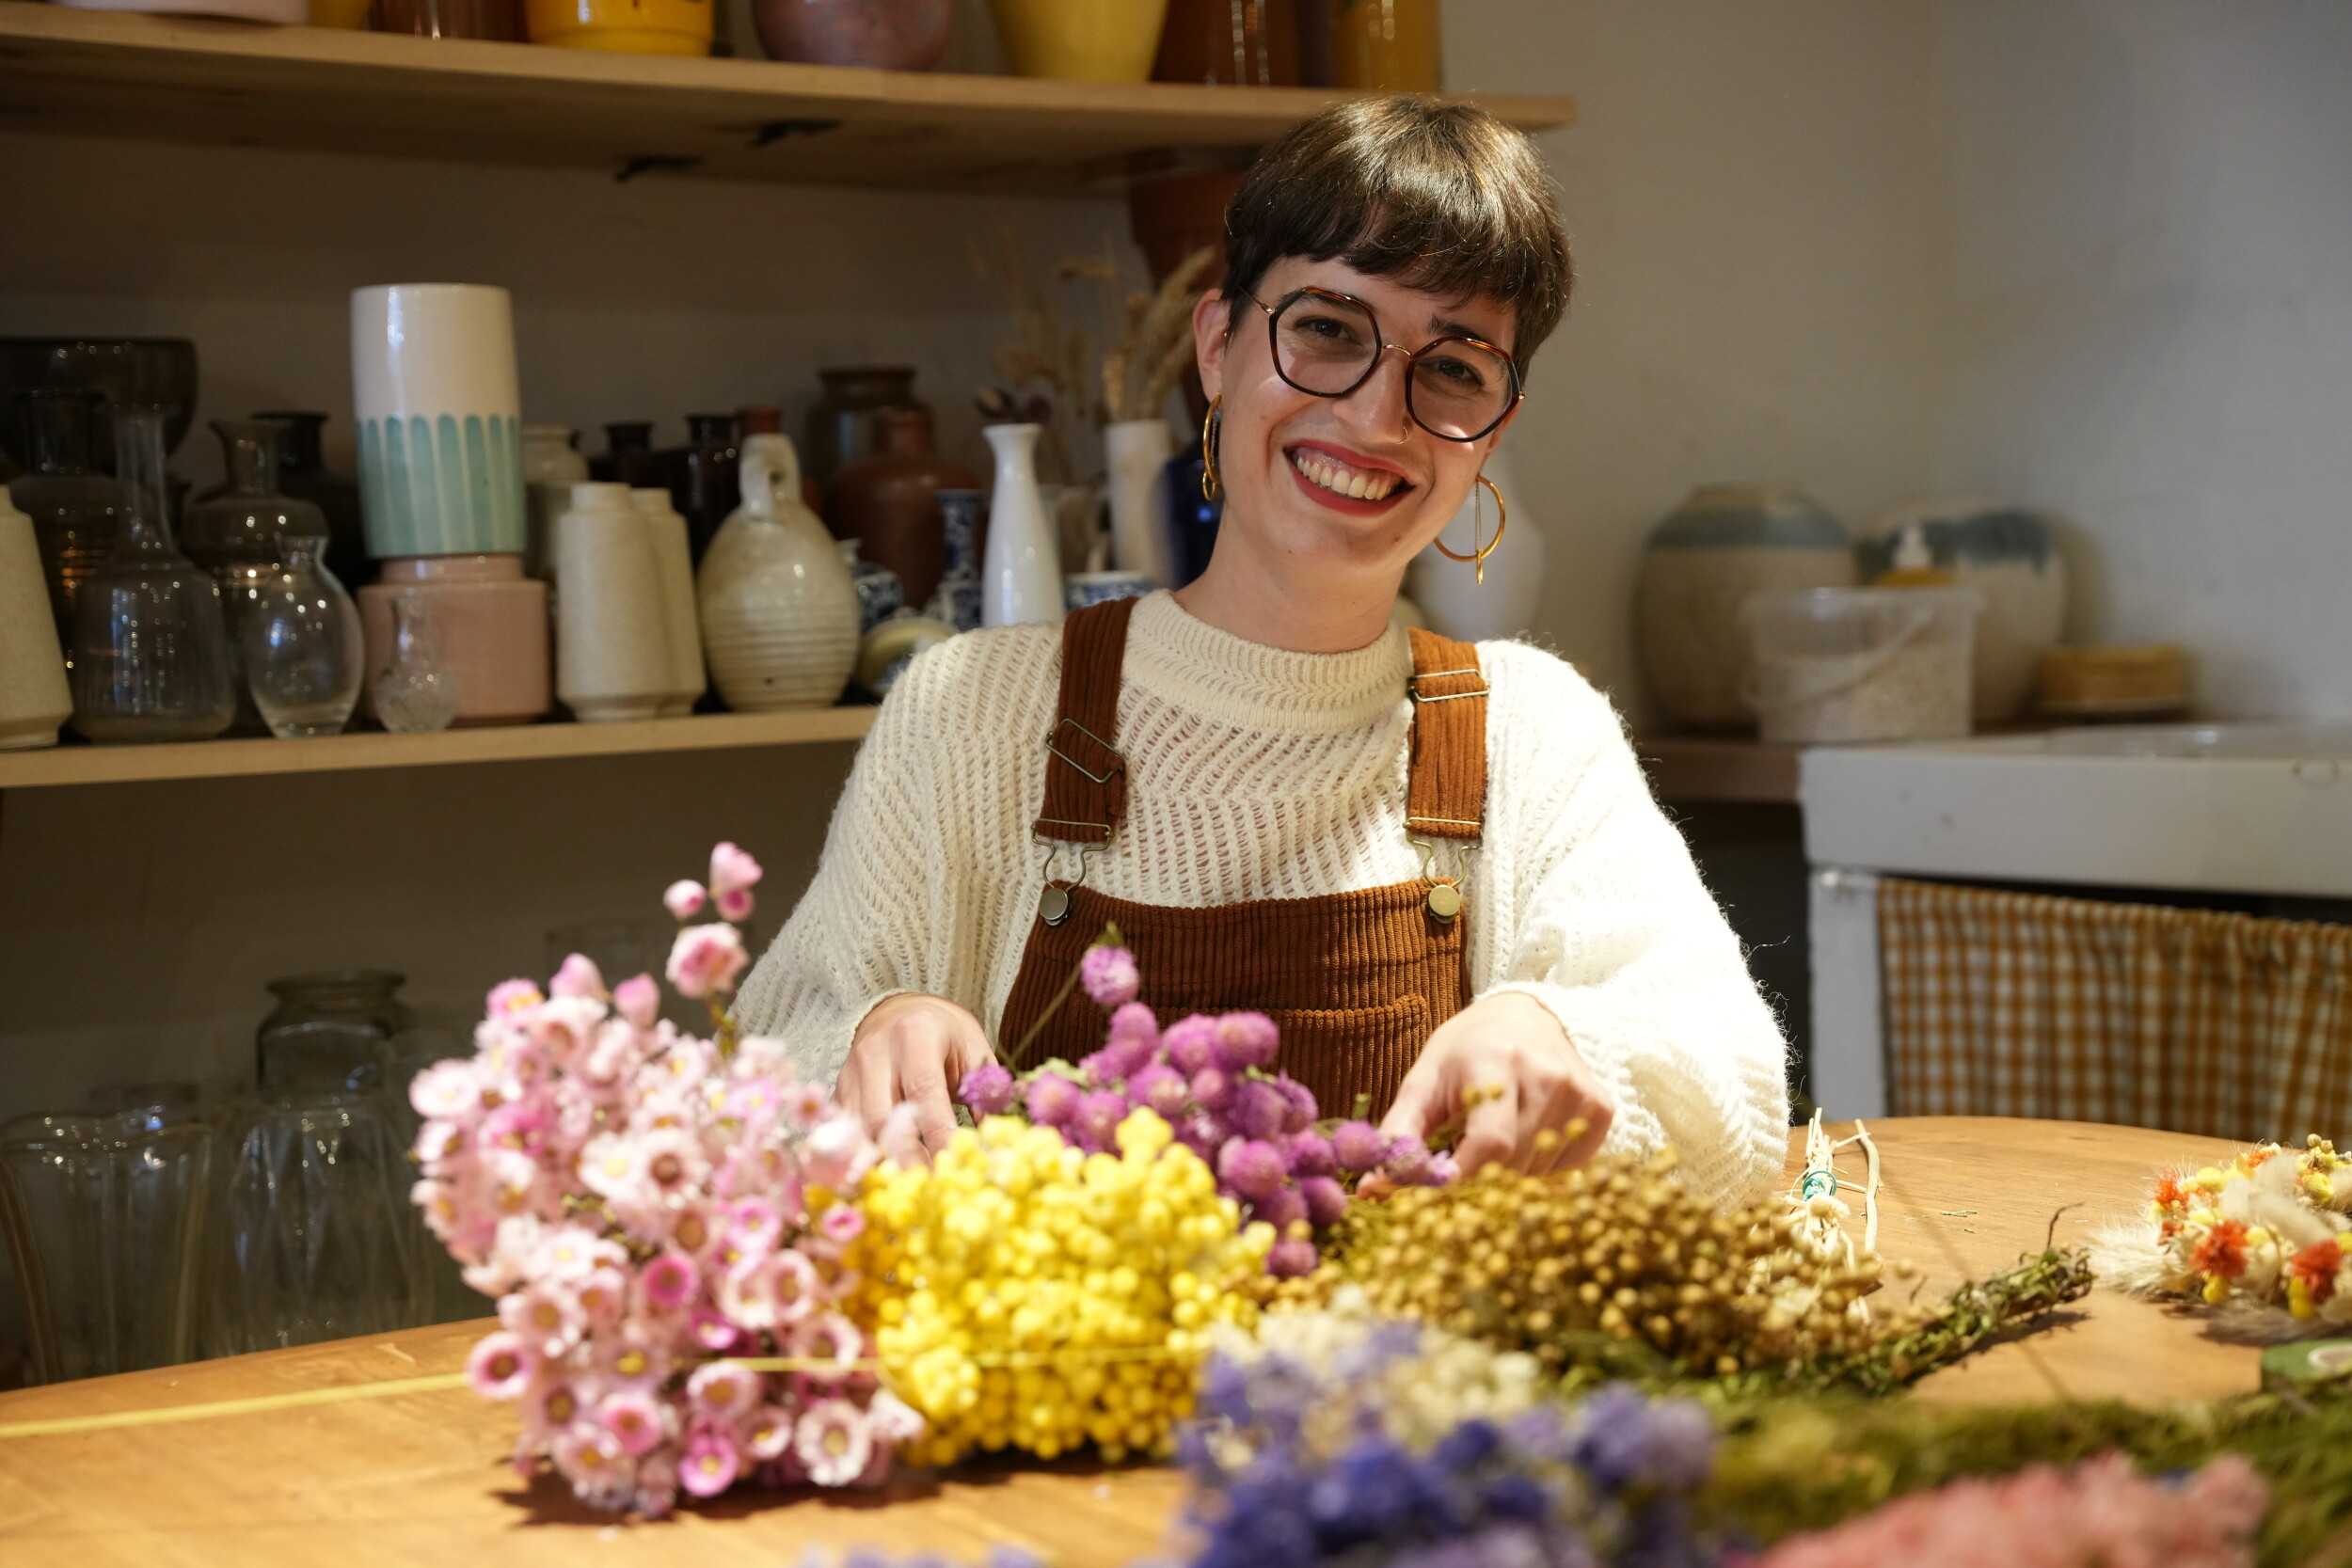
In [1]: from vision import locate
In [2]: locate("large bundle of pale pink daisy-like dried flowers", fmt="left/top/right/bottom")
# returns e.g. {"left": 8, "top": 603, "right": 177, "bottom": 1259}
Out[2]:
{"left": 409, "top": 844, "right": 922, "bottom": 1516}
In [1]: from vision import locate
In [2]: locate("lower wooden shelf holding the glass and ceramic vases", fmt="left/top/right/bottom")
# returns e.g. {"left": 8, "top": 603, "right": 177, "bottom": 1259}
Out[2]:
{"left": 0, "top": 707, "right": 878, "bottom": 790}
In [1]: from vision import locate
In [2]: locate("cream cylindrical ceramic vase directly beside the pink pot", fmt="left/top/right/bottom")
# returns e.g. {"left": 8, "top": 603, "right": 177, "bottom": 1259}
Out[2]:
{"left": 550, "top": 484, "right": 671, "bottom": 724}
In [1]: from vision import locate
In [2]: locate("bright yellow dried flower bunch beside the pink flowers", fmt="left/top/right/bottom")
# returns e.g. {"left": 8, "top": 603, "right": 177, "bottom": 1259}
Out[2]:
{"left": 847, "top": 1110, "right": 1275, "bottom": 1465}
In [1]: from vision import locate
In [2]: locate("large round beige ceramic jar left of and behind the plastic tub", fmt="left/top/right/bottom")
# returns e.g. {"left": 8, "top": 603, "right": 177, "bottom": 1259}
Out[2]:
{"left": 1635, "top": 484, "right": 1856, "bottom": 729}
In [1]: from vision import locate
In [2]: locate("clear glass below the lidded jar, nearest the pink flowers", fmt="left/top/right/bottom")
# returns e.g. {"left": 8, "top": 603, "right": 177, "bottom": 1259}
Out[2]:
{"left": 205, "top": 1091, "right": 431, "bottom": 1356}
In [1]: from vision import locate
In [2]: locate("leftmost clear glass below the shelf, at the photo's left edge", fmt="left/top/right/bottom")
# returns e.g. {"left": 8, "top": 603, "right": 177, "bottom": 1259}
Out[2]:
{"left": 0, "top": 1107, "right": 212, "bottom": 1383}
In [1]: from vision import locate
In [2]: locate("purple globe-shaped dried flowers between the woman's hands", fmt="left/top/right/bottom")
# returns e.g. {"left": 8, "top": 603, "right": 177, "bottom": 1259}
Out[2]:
{"left": 958, "top": 933, "right": 1456, "bottom": 1279}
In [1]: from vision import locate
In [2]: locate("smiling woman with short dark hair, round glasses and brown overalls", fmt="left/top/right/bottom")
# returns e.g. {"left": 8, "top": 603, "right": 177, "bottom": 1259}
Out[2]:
{"left": 739, "top": 99, "right": 1788, "bottom": 1199}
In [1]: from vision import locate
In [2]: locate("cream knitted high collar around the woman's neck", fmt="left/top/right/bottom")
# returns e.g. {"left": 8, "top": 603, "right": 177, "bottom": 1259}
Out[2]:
{"left": 1124, "top": 593, "right": 1414, "bottom": 736}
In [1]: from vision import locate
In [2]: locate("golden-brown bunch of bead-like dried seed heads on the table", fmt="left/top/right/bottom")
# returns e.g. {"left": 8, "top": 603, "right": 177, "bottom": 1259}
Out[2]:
{"left": 1278, "top": 1132, "right": 1924, "bottom": 1378}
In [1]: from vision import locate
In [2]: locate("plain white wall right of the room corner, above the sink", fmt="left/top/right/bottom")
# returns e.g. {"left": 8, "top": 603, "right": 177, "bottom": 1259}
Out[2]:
{"left": 1931, "top": 0, "right": 2352, "bottom": 720}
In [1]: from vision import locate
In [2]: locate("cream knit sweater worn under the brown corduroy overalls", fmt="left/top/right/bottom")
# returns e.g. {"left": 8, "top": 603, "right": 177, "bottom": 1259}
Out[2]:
{"left": 739, "top": 593, "right": 1788, "bottom": 1201}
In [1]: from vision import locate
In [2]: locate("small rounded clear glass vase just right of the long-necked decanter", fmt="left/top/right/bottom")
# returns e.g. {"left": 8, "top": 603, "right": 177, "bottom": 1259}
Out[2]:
{"left": 240, "top": 533, "right": 367, "bottom": 740}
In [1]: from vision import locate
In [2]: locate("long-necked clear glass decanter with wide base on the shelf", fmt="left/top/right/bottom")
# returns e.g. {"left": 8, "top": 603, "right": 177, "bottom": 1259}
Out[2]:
{"left": 73, "top": 406, "right": 238, "bottom": 743}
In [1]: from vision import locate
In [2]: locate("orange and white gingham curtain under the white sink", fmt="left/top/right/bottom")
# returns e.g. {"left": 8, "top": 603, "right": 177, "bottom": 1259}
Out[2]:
{"left": 1880, "top": 877, "right": 2352, "bottom": 1143}
